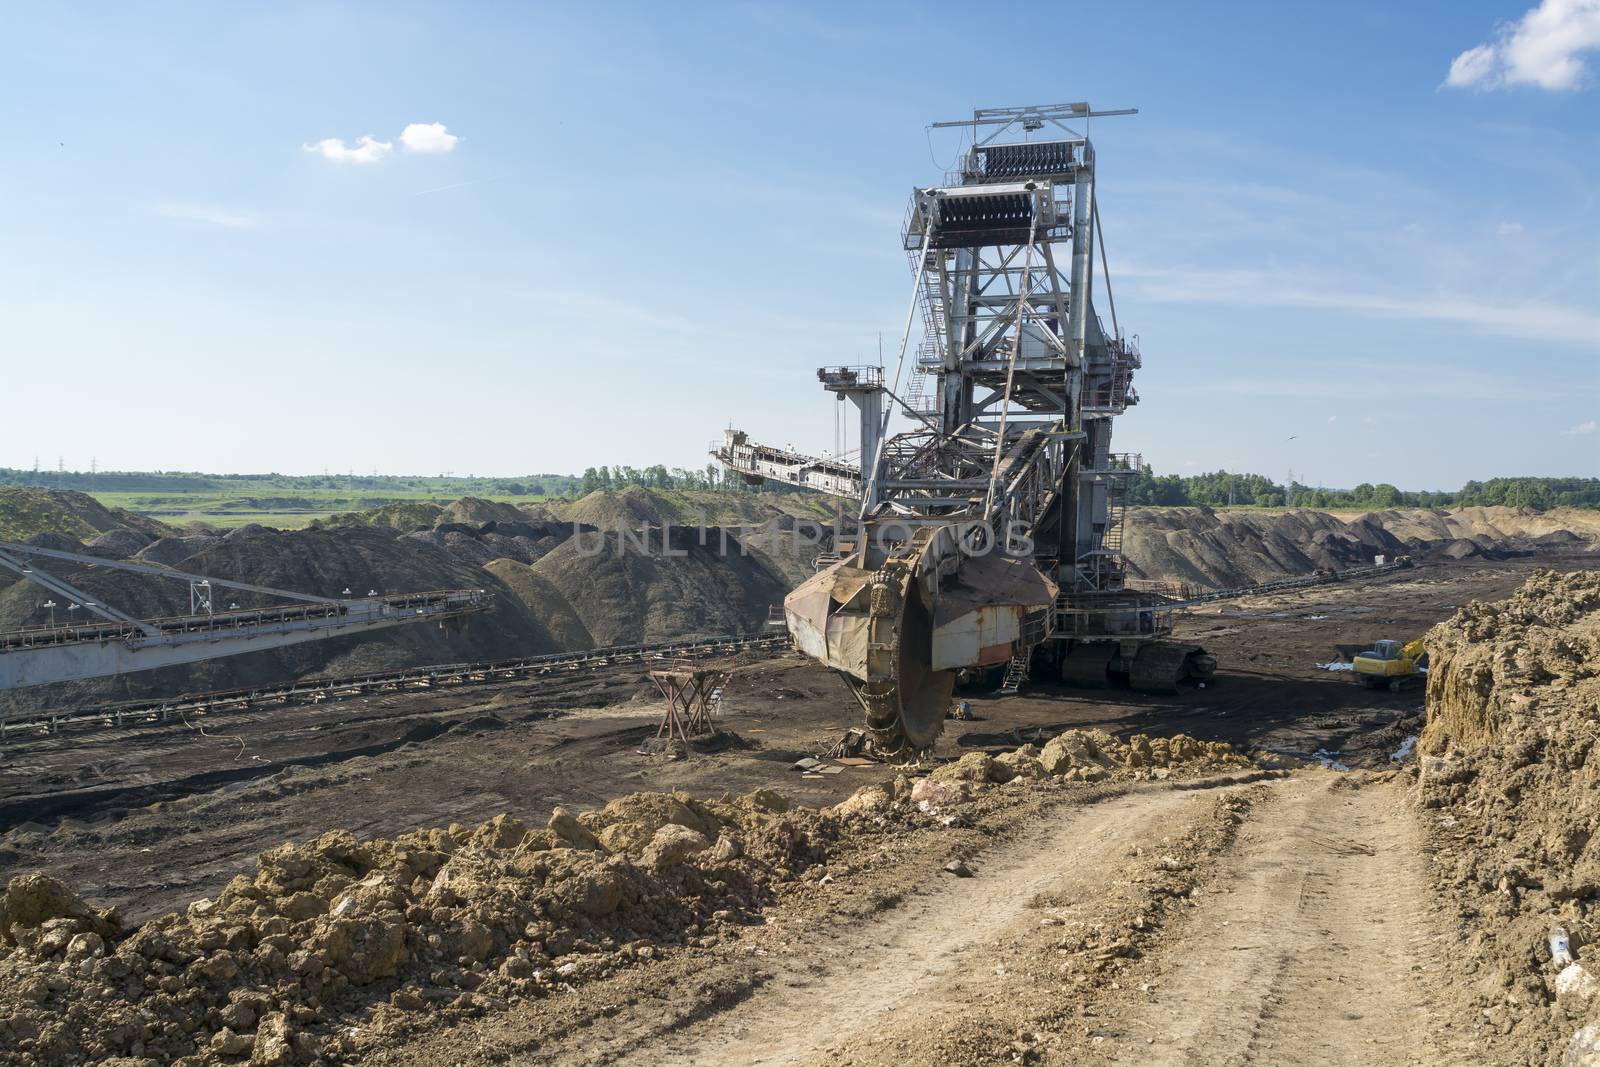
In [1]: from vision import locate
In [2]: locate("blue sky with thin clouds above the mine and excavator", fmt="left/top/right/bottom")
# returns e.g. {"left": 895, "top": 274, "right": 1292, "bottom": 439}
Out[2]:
{"left": 0, "top": 0, "right": 1600, "bottom": 488}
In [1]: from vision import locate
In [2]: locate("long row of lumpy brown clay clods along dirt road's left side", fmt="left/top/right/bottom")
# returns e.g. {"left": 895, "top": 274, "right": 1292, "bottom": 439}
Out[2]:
{"left": 0, "top": 731, "right": 1248, "bottom": 1067}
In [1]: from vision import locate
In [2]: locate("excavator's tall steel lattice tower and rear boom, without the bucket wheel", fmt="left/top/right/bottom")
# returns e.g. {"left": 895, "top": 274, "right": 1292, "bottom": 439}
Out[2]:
{"left": 712, "top": 104, "right": 1166, "bottom": 638}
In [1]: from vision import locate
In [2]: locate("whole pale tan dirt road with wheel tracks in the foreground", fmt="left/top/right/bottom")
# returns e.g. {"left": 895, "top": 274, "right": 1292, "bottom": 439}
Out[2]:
{"left": 376, "top": 771, "right": 1483, "bottom": 1067}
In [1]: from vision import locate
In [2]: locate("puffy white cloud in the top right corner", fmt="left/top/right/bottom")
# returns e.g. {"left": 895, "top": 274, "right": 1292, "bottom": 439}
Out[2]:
{"left": 1445, "top": 0, "right": 1600, "bottom": 91}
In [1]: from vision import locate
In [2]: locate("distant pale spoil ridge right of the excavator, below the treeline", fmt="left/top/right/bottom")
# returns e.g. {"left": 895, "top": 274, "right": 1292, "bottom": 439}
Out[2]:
{"left": 1123, "top": 507, "right": 1600, "bottom": 589}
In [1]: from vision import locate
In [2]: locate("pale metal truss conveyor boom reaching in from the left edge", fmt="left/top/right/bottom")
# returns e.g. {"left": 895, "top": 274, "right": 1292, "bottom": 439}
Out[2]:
{"left": 0, "top": 542, "right": 494, "bottom": 691}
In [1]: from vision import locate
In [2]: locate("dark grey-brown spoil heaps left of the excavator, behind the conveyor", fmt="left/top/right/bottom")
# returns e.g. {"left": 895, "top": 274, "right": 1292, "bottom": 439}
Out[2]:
{"left": 0, "top": 490, "right": 814, "bottom": 713}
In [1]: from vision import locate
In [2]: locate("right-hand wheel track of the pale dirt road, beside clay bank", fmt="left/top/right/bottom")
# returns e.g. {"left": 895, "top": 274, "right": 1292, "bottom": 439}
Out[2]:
{"left": 1114, "top": 774, "right": 1474, "bottom": 1065}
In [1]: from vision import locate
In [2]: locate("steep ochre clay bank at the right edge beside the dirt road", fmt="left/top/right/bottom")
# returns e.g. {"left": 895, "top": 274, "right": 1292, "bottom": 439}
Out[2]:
{"left": 1419, "top": 571, "right": 1600, "bottom": 1067}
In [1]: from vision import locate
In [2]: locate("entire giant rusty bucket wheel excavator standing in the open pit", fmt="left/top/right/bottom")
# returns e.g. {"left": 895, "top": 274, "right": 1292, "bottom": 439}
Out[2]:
{"left": 712, "top": 97, "right": 1216, "bottom": 757}
